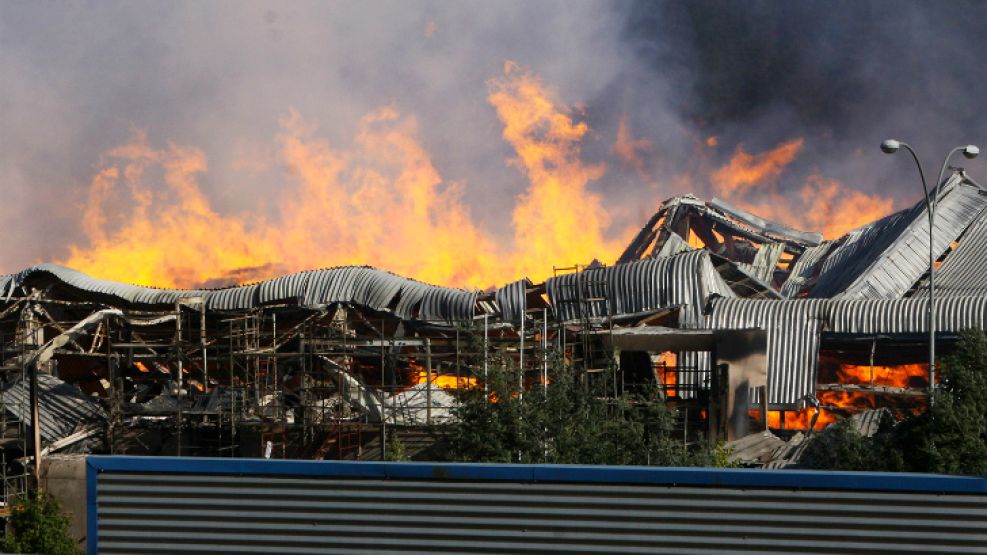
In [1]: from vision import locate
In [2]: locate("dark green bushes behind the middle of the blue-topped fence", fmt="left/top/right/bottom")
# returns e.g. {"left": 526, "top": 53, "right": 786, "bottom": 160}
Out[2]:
{"left": 446, "top": 367, "right": 715, "bottom": 466}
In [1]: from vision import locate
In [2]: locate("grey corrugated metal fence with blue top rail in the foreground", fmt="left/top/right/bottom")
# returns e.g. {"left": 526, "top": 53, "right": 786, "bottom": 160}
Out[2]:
{"left": 87, "top": 457, "right": 987, "bottom": 553}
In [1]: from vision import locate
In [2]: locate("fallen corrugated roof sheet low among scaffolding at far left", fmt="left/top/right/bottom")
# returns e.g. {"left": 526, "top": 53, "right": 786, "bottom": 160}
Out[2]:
{"left": 0, "top": 372, "right": 106, "bottom": 443}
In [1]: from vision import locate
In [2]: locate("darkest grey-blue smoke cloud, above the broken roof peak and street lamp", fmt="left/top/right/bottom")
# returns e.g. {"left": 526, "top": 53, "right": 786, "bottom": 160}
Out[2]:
{"left": 625, "top": 0, "right": 987, "bottom": 195}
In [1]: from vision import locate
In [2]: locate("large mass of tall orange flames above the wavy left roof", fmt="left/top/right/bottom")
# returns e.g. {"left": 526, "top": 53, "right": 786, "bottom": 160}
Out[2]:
{"left": 62, "top": 63, "right": 630, "bottom": 287}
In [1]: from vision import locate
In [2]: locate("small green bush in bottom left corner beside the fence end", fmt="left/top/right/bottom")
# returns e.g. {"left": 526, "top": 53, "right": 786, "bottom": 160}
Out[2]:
{"left": 3, "top": 494, "right": 81, "bottom": 555}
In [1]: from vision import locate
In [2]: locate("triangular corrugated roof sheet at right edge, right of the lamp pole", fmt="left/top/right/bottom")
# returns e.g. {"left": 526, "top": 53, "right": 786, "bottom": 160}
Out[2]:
{"left": 936, "top": 207, "right": 987, "bottom": 296}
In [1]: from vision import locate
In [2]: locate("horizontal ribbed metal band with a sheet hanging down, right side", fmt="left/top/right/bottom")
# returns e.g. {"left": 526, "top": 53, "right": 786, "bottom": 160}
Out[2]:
{"left": 706, "top": 297, "right": 987, "bottom": 408}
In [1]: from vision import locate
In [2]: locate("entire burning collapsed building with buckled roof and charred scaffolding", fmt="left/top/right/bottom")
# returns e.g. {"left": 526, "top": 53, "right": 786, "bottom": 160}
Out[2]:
{"left": 0, "top": 172, "right": 987, "bottom": 496}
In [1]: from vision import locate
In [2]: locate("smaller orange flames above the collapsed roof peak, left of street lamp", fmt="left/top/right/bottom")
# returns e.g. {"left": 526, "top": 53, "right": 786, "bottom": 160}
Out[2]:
{"left": 711, "top": 138, "right": 894, "bottom": 239}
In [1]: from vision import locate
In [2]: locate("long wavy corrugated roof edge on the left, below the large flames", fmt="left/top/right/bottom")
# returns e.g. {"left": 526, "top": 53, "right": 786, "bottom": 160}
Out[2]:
{"left": 0, "top": 264, "right": 477, "bottom": 324}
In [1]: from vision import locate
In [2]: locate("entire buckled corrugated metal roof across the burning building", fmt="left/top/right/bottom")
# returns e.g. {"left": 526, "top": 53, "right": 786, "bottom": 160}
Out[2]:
{"left": 0, "top": 171, "right": 987, "bottom": 408}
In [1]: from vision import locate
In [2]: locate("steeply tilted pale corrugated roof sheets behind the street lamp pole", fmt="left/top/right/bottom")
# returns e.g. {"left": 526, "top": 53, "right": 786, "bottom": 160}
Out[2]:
{"left": 810, "top": 174, "right": 987, "bottom": 299}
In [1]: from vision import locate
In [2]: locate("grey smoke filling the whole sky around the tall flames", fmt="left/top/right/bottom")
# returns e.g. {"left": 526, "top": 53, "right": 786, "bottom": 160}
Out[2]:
{"left": 0, "top": 0, "right": 987, "bottom": 285}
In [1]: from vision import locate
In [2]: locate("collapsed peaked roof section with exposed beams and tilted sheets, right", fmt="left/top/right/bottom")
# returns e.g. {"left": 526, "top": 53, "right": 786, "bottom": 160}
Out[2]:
{"left": 619, "top": 172, "right": 987, "bottom": 299}
